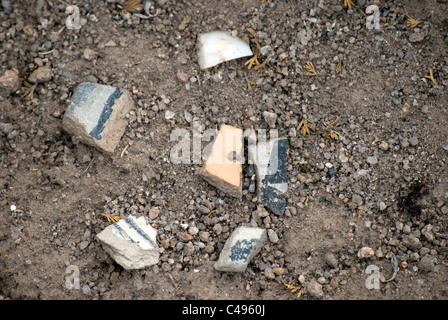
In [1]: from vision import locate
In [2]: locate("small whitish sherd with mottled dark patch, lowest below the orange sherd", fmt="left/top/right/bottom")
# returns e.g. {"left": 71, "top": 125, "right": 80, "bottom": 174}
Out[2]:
{"left": 214, "top": 226, "right": 267, "bottom": 272}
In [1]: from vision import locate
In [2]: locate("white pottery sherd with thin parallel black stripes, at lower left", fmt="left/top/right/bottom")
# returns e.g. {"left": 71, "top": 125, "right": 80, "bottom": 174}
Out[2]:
{"left": 96, "top": 215, "right": 160, "bottom": 270}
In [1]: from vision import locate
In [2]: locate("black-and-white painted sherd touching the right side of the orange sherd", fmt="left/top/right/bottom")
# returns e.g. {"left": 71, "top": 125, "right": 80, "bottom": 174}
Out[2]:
{"left": 248, "top": 138, "right": 289, "bottom": 215}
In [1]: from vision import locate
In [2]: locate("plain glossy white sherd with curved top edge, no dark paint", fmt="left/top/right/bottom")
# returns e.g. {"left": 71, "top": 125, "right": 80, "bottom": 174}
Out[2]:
{"left": 197, "top": 31, "right": 253, "bottom": 70}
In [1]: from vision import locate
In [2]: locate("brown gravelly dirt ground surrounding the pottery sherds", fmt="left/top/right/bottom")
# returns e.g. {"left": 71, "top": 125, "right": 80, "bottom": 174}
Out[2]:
{"left": 0, "top": 0, "right": 448, "bottom": 300}
